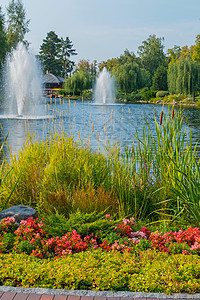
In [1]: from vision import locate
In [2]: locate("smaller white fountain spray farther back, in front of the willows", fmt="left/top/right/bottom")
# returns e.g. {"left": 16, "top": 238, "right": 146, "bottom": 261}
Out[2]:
{"left": 94, "top": 68, "right": 115, "bottom": 104}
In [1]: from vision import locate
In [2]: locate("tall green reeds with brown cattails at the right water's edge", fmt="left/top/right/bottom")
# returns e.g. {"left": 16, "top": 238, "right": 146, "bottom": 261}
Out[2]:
{"left": 114, "top": 110, "right": 197, "bottom": 219}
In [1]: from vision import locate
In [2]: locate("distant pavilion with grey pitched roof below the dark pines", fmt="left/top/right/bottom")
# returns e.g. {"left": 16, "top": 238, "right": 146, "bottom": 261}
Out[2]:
{"left": 42, "top": 72, "right": 65, "bottom": 97}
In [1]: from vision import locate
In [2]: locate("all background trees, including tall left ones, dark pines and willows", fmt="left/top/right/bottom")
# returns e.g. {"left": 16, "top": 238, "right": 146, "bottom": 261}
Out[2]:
{"left": 0, "top": 0, "right": 200, "bottom": 96}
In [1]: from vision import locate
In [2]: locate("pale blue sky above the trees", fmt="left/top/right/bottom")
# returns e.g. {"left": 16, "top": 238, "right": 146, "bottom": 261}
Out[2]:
{"left": 0, "top": 0, "right": 200, "bottom": 62}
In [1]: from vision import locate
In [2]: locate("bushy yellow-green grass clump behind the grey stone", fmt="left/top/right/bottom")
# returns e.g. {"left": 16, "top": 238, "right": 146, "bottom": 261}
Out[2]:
{"left": 1, "top": 135, "right": 119, "bottom": 215}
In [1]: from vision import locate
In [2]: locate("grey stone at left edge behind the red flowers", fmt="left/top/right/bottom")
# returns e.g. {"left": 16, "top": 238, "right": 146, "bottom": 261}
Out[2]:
{"left": 0, "top": 205, "right": 38, "bottom": 223}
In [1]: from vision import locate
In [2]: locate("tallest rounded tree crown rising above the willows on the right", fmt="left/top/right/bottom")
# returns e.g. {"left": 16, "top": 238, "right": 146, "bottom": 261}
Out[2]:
{"left": 138, "top": 34, "right": 166, "bottom": 76}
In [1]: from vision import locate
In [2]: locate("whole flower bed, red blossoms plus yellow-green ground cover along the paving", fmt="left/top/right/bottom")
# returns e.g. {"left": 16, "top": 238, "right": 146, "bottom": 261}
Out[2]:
{"left": 0, "top": 214, "right": 200, "bottom": 294}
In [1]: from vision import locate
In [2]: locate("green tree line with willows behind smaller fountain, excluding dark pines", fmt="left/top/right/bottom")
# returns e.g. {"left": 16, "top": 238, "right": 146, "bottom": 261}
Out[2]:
{"left": 65, "top": 34, "right": 200, "bottom": 99}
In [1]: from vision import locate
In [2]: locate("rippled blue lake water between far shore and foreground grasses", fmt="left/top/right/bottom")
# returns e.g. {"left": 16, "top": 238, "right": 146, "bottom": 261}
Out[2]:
{"left": 0, "top": 99, "right": 200, "bottom": 156}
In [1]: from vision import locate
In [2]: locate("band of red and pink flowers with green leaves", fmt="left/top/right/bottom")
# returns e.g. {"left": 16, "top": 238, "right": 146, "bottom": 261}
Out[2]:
{"left": 0, "top": 215, "right": 200, "bottom": 258}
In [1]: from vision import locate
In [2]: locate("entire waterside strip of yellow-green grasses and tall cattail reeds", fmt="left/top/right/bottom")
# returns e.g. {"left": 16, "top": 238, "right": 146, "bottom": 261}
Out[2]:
{"left": 0, "top": 110, "right": 199, "bottom": 220}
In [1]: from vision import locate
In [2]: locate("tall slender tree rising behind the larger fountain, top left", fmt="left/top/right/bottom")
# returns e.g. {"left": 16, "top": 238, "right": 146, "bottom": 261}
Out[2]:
{"left": 7, "top": 0, "right": 30, "bottom": 51}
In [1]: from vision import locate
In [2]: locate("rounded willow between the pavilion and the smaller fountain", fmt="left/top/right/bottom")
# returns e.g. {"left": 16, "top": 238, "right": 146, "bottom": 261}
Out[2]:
{"left": 64, "top": 71, "right": 92, "bottom": 95}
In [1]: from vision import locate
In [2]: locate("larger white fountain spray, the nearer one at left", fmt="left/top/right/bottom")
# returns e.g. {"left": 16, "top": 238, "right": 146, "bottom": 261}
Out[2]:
{"left": 4, "top": 43, "right": 42, "bottom": 117}
